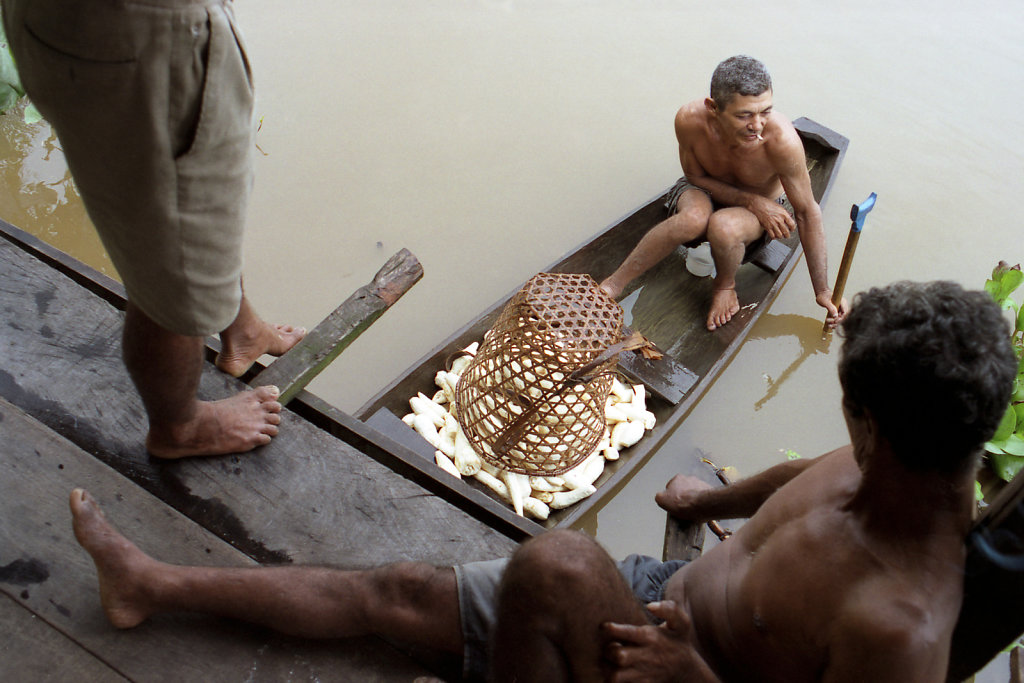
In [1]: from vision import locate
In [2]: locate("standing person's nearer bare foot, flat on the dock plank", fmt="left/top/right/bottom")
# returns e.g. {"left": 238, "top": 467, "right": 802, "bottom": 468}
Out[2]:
{"left": 145, "top": 386, "right": 281, "bottom": 459}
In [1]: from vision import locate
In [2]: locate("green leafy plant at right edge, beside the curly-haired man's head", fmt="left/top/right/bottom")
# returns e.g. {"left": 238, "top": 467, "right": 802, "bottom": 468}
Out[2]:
{"left": 985, "top": 261, "right": 1024, "bottom": 481}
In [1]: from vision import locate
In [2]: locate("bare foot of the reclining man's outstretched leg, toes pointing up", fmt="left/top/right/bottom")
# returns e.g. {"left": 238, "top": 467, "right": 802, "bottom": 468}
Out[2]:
{"left": 71, "top": 488, "right": 157, "bottom": 629}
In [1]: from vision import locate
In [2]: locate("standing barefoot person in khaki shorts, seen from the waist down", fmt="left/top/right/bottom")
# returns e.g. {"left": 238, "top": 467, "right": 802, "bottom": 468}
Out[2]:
{"left": 3, "top": 0, "right": 305, "bottom": 458}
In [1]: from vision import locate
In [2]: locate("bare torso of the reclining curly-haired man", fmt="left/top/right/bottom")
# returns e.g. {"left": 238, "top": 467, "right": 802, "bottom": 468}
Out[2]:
{"left": 666, "top": 450, "right": 964, "bottom": 683}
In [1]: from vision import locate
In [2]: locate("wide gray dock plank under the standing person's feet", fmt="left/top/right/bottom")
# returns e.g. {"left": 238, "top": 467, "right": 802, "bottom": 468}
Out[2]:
{"left": 0, "top": 224, "right": 521, "bottom": 567}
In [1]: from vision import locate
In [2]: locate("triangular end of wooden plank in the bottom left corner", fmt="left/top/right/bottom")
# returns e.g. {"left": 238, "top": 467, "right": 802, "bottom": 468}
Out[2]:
{"left": 0, "top": 593, "right": 128, "bottom": 681}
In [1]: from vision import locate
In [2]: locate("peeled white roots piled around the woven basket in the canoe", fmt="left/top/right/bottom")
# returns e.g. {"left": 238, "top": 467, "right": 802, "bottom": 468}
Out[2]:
{"left": 402, "top": 343, "right": 654, "bottom": 520}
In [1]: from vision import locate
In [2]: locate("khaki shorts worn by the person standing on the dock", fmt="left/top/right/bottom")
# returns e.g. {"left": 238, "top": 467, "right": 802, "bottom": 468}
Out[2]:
{"left": 3, "top": 0, "right": 254, "bottom": 336}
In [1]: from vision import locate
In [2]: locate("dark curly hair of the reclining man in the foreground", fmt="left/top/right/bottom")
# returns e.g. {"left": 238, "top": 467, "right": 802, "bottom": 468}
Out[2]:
{"left": 839, "top": 282, "right": 1018, "bottom": 473}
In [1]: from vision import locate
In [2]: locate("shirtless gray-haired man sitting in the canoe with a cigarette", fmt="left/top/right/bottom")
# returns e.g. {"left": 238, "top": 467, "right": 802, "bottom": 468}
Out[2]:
{"left": 601, "top": 55, "right": 846, "bottom": 330}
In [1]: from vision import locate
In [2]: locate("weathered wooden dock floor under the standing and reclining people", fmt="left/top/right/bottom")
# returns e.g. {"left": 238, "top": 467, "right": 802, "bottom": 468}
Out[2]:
{"left": 0, "top": 226, "right": 515, "bottom": 681}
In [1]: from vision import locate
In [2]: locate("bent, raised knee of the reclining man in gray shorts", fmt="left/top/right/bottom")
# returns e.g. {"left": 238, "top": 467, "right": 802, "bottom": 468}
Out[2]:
{"left": 490, "top": 531, "right": 647, "bottom": 681}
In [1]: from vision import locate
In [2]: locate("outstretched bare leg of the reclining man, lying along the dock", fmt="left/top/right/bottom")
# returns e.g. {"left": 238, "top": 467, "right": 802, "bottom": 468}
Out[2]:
{"left": 71, "top": 488, "right": 462, "bottom": 653}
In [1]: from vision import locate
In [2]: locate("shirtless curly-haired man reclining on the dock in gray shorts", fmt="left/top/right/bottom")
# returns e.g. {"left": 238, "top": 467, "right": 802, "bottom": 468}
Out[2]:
{"left": 71, "top": 283, "right": 1017, "bottom": 683}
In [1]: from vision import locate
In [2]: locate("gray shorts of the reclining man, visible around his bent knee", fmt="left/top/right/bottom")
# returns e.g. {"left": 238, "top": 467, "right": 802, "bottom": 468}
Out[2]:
{"left": 455, "top": 555, "right": 686, "bottom": 681}
